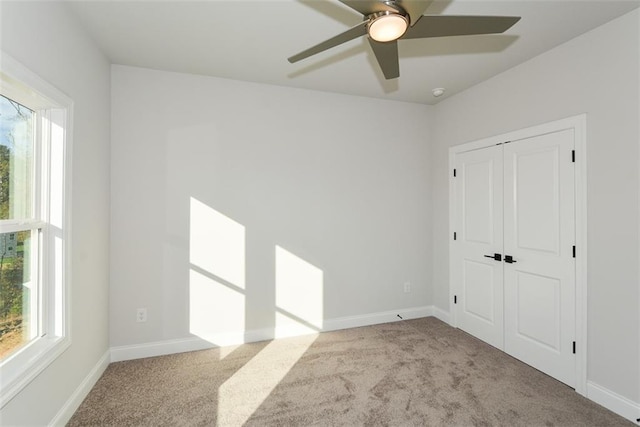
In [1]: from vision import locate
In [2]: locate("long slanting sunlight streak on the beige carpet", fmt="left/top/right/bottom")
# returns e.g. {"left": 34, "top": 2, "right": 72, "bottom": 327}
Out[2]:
{"left": 217, "top": 334, "right": 317, "bottom": 426}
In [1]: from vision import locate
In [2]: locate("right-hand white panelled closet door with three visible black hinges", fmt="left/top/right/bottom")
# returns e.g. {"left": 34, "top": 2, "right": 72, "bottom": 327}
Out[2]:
{"left": 504, "top": 129, "right": 576, "bottom": 387}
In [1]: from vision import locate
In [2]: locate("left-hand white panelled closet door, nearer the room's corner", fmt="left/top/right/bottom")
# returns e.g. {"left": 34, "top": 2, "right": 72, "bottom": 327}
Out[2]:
{"left": 451, "top": 146, "right": 504, "bottom": 349}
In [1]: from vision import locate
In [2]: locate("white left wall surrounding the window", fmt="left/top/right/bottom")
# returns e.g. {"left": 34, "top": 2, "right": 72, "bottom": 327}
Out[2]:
{"left": 0, "top": 2, "right": 110, "bottom": 425}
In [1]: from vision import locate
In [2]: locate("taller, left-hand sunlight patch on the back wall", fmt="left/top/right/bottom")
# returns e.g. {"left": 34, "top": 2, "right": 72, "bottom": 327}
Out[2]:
{"left": 189, "top": 197, "right": 246, "bottom": 346}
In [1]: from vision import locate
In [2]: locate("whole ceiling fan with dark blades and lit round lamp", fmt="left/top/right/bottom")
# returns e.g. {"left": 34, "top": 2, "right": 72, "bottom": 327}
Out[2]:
{"left": 288, "top": 0, "right": 520, "bottom": 79}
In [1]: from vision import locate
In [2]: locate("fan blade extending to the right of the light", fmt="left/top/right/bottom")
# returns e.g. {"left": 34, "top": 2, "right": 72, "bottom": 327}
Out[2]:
{"left": 402, "top": 15, "right": 520, "bottom": 39}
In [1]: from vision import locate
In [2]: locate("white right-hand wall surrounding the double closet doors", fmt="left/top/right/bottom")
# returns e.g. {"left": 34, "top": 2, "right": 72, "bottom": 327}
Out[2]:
{"left": 431, "top": 11, "right": 640, "bottom": 402}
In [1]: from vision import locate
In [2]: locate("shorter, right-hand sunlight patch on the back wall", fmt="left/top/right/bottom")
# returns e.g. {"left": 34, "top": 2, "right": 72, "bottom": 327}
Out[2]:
{"left": 275, "top": 246, "right": 324, "bottom": 338}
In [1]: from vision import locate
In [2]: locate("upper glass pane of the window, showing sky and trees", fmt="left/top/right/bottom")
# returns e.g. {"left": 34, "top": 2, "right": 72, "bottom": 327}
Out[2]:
{"left": 0, "top": 95, "right": 35, "bottom": 219}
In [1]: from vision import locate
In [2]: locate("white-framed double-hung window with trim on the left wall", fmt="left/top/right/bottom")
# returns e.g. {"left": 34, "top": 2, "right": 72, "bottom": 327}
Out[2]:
{"left": 0, "top": 52, "right": 72, "bottom": 407}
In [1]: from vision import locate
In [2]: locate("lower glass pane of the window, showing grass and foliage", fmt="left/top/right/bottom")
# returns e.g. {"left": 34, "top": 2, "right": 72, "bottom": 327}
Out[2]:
{"left": 0, "top": 230, "right": 38, "bottom": 360}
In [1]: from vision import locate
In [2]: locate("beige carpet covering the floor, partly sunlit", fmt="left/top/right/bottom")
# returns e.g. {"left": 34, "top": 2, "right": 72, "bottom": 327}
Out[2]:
{"left": 69, "top": 318, "right": 633, "bottom": 426}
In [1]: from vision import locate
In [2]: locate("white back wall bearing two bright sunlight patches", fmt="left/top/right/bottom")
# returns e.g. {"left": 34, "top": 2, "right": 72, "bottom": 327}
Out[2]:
{"left": 110, "top": 66, "right": 431, "bottom": 346}
